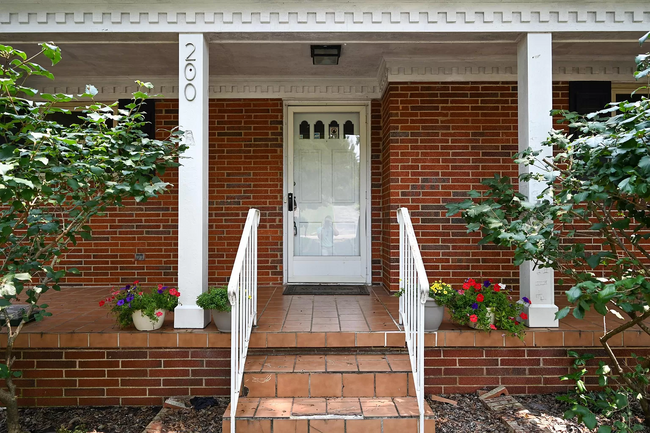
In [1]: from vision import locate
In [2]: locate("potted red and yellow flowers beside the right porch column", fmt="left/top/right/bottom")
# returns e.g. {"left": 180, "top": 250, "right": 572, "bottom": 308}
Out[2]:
{"left": 435, "top": 278, "right": 530, "bottom": 339}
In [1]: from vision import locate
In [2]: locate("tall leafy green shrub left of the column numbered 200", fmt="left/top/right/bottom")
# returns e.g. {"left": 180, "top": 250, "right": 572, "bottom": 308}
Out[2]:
{"left": 0, "top": 43, "right": 186, "bottom": 433}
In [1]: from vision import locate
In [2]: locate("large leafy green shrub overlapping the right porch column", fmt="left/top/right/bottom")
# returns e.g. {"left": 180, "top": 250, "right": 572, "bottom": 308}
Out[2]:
{"left": 447, "top": 33, "right": 650, "bottom": 431}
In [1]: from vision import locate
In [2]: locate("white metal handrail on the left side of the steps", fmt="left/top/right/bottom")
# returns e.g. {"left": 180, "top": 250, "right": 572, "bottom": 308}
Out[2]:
{"left": 228, "top": 209, "right": 260, "bottom": 433}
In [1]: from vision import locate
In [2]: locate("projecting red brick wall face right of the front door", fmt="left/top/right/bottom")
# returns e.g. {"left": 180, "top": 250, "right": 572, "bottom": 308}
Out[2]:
{"left": 382, "top": 82, "right": 568, "bottom": 290}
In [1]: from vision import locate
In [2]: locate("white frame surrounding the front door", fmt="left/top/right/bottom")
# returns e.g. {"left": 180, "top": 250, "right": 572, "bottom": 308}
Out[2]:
{"left": 282, "top": 100, "right": 372, "bottom": 284}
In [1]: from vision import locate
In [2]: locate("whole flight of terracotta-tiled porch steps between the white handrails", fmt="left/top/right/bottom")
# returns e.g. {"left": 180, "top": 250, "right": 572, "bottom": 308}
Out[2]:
{"left": 223, "top": 351, "right": 435, "bottom": 433}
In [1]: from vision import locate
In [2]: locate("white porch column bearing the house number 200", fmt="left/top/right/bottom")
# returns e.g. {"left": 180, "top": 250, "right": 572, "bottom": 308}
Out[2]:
{"left": 174, "top": 34, "right": 210, "bottom": 328}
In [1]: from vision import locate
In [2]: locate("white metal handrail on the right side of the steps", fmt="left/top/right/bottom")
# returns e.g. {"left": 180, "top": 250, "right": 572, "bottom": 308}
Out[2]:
{"left": 397, "top": 207, "right": 429, "bottom": 433}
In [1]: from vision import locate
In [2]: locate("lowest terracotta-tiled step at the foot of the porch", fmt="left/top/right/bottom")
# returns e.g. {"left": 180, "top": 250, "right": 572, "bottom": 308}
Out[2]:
{"left": 223, "top": 397, "right": 435, "bottom": 433}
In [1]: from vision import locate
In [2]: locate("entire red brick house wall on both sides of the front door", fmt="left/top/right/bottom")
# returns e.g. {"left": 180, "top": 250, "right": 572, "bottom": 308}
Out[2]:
{"left": 58, "top": 83, "right": 568, "bottom": 289}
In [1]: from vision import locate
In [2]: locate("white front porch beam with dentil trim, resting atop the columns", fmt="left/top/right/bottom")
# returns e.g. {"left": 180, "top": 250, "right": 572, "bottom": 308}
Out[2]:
{"left": 0, "top": 0, "right": 650, "bottom": 33}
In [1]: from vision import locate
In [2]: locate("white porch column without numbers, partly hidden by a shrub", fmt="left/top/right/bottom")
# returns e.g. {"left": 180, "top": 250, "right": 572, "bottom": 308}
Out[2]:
{"left": 517, "top": 33, "right": 558, "bottom": 328}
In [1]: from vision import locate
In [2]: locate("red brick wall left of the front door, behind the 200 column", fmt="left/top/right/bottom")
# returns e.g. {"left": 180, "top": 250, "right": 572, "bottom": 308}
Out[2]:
{"left": 64, "top": 99, "right": 282, "bottom": 285}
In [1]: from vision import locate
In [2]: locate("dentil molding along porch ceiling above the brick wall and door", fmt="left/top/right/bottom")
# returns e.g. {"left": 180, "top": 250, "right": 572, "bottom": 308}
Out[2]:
{"left": 29, "top": 60, "right": 635, "bottom": 100}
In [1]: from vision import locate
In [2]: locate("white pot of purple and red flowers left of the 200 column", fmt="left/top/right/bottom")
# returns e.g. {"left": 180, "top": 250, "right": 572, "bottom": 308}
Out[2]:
{"left": 99, "top": 281, "right": 181, "bottom": 331}
